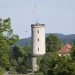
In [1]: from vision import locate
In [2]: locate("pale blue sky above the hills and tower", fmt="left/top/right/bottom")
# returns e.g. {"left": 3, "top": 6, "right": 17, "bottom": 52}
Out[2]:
{"left": 0, "top": 0, "right": 75, "bottom": 39}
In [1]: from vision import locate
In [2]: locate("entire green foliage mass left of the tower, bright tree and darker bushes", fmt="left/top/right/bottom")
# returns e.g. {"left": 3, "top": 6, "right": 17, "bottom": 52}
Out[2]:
{"left": 0, "top": 18, "right": 31, "bottom": 73}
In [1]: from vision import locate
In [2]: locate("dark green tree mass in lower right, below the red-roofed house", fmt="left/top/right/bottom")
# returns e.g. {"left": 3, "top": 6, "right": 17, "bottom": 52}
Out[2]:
{"left": 40, "top": 53, "right": 75, "bottom": 75}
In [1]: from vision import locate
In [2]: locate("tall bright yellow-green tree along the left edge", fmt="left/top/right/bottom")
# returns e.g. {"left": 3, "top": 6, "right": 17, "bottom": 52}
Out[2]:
{"left": 0, "top": 18, "right": 19, "bottom": 69}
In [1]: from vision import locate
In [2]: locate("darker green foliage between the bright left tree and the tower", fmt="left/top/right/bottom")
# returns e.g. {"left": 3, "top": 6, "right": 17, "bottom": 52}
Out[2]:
{"left": 10, "top": 46, "right": 31, "bottom": 73}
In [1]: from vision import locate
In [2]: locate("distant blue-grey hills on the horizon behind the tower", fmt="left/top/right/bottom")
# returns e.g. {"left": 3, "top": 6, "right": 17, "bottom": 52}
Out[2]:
{"left": 16, "top": 33, "right": 75, "bottom": 46}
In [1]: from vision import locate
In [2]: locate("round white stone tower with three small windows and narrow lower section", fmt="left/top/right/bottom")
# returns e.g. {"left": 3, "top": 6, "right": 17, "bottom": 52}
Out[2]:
{"left": 31, "top": 23, "right": 46, "bottom": 72}
